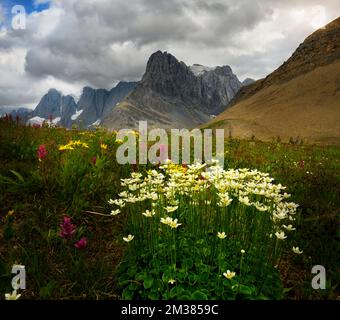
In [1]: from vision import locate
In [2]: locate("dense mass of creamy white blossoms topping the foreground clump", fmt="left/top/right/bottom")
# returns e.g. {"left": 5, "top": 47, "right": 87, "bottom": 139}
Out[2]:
{"left": 109, "top": 160, "right": 298, "bottom": 240}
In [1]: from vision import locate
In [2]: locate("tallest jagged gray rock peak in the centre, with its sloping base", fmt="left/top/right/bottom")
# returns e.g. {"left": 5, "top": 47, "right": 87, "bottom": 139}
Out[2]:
{"left": 103, "top": 51, "right": 242, "bottom": 129}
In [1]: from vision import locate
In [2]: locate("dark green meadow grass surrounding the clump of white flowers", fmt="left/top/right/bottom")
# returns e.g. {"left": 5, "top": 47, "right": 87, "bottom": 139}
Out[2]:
{"left": 0, "top": 121, "right": 340, "bottom": 299}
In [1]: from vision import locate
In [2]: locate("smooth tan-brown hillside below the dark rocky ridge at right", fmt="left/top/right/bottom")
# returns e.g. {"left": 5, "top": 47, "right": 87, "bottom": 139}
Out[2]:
{"left": 208, "top": 61, "right": 340, "bottom": 144}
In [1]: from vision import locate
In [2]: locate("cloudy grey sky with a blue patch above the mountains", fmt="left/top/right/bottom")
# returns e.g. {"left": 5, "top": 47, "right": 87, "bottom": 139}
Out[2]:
{"left": 0, "top": 0, "right": 340, "bottom": 108}
